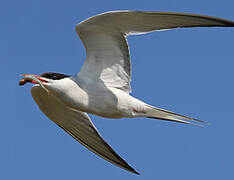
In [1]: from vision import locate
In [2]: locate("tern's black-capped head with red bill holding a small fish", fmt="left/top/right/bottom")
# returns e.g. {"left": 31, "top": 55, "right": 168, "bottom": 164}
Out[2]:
{"left": 19, "top": 72, "right": 69, "bottom": 86}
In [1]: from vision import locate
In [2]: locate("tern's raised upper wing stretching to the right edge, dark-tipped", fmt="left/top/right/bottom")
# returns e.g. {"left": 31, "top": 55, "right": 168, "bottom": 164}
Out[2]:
{"left": 76, "top": 11, "right": 234, "bottom": 92}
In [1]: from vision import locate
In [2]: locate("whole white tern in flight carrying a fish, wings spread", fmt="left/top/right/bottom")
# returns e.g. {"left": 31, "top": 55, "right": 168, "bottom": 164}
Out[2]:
{"left": 19, "top": 11, "right": 234, "bottom": 174}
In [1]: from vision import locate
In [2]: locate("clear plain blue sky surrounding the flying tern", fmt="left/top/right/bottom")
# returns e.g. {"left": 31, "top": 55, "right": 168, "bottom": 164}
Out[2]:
{"left": 0, "top": 0, "right": 234, "bottom": 180}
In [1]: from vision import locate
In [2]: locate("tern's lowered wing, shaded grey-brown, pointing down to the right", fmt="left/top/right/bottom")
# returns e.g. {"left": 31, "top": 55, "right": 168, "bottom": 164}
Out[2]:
{"left": 31, "top": 86, "right": 139, "bottom": 174}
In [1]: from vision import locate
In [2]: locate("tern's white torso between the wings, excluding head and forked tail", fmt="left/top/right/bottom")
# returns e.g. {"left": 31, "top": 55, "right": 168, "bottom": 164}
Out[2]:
{"left": 35, "top": 76, "right": 145, "bottom": 118}
